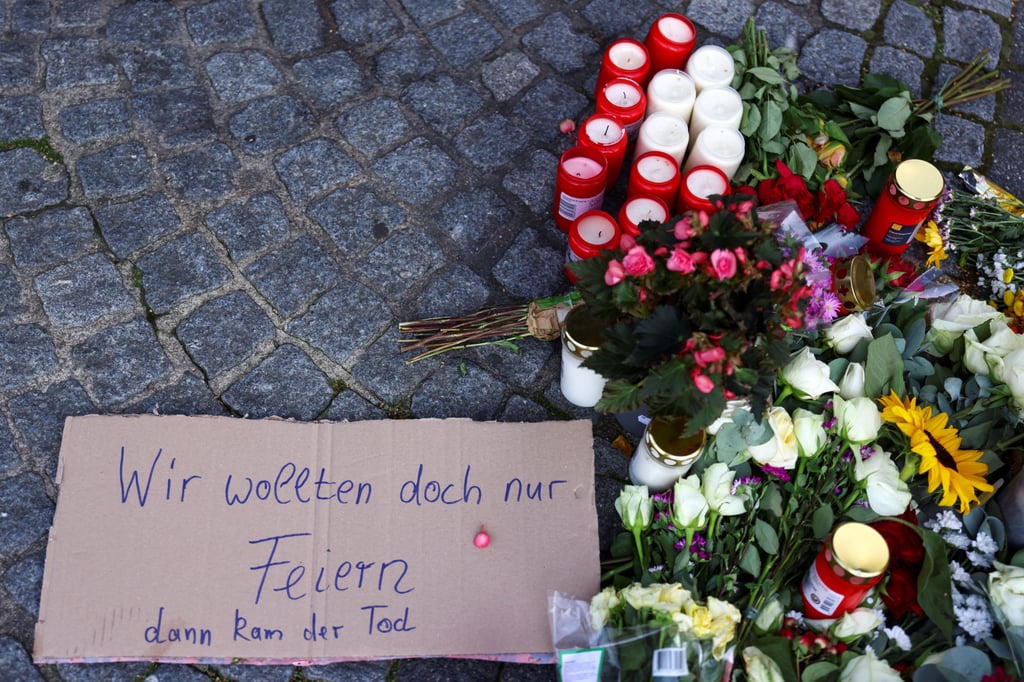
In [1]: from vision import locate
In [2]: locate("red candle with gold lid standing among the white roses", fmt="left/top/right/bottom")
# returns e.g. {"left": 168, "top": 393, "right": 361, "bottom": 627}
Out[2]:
{"left": 801, "top": 521, "right": 889, "bottom": 619}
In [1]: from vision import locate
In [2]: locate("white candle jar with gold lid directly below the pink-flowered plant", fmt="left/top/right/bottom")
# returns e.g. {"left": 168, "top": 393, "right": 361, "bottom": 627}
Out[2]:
{"left": 630, "top": 417, "right": 707, "bottom": 493}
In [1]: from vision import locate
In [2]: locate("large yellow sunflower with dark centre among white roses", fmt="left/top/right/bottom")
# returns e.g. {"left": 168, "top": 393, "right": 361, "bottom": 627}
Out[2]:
{"left": 880, "top": 391, "right": 993, "bottom": 514}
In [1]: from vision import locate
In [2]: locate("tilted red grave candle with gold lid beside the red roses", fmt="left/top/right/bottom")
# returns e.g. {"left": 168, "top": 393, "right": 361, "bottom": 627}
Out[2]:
{"left": 861, "top": 159, "right": 945, "bottom": 256}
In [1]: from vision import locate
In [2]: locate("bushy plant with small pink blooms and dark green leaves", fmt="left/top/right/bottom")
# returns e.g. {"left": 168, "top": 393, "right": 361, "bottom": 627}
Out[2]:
{"left": 569, "top": 195, "right": 831, "bottom": 433}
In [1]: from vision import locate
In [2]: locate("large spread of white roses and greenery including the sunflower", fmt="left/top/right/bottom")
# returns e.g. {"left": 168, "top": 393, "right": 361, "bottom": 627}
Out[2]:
{"left": 581, "top": 284, "right": 1024, "bottom": 680}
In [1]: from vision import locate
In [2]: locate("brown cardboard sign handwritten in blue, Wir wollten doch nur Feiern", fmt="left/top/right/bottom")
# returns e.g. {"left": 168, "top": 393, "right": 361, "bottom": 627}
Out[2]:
{"left": 34, "top": 416, "right": 599, "bottom": 664}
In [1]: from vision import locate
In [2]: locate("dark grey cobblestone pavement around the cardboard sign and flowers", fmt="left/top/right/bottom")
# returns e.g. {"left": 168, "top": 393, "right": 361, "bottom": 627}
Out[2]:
{"left": 0, "top": 0, "right": 1024, "bottom": 682}
